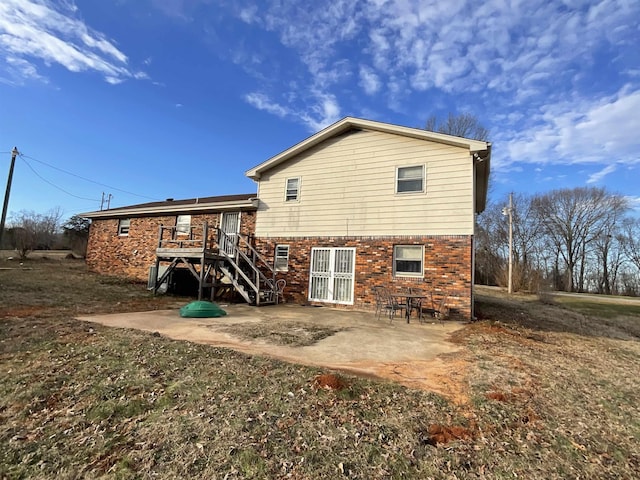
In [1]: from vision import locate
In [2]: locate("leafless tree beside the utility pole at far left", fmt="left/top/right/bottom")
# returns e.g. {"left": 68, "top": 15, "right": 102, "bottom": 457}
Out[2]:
{"left": 10, "top": 207, "right": 62, "bottom": 259}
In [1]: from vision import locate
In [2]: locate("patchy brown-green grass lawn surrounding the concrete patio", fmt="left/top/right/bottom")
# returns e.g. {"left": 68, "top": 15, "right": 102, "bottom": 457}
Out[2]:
{"left": 0, "top": 260, "right": 640, "bottom": 479}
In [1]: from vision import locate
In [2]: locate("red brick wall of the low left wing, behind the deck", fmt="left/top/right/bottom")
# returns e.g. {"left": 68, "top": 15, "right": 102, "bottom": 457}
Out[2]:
{"left": 87, "top": 211, "right": 256, "bottom": 281}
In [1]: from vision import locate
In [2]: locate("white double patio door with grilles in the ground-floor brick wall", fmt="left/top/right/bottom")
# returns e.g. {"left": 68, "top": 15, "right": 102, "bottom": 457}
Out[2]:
{"left": 309, "top": 248, "right": 356, "bottom": 304}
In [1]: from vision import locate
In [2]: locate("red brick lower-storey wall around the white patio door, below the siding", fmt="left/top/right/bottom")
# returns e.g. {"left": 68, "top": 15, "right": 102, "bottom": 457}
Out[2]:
{"left": 256, "top": 236, "right": 472, "bottom": 319}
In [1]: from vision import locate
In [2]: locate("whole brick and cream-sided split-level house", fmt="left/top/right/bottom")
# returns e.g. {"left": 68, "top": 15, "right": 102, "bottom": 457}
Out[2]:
{"left": 84, "top": 117, "right": 491, "bottom": 318}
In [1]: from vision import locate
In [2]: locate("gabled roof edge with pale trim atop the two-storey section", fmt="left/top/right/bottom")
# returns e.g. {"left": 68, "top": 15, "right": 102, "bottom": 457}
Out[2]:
{"left": 245, "top": 117, "right": 491, "bottom": 213}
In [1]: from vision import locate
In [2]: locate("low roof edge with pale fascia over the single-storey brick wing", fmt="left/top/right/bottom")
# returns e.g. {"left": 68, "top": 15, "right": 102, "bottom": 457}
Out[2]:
{"left": 79, "top": 193, "right": 258, "bottom": 218}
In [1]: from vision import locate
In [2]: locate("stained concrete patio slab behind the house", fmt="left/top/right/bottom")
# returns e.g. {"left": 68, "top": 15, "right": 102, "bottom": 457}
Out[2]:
{"left": 78, "top": 304, "right": 464, "bottom": 390}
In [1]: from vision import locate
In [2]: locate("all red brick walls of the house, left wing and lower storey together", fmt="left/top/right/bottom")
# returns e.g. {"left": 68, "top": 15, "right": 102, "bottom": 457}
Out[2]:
{"left": 87, "top": 211, "right": 472, "bottom": 319}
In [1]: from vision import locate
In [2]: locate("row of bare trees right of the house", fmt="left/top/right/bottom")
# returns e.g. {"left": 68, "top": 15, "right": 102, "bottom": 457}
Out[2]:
{"left": 475, "top": 187, "right": 640, "bottom": 296}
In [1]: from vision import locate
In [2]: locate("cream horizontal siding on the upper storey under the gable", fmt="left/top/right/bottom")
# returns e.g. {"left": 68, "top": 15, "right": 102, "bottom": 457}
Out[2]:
{"left": 256, "top": 131, "right": 473, "bottom": 237}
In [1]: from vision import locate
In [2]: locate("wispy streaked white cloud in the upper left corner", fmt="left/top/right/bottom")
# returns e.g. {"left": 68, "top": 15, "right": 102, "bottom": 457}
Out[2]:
{"left": 0, "top": 0, "right": 147, "bottom": 84}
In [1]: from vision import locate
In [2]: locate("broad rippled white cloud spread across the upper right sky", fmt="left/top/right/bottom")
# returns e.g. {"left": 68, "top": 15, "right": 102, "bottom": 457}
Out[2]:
{"left": 206, "top": 0, "right": 640, "bottom": 139}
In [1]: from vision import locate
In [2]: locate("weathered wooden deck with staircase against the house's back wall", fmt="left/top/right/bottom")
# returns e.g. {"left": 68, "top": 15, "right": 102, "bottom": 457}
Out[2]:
{"left": 149, "top": 223, "right": 284, "bottom": 305}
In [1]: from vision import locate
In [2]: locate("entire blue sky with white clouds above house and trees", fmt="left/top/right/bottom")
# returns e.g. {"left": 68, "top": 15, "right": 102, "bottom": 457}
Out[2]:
{"left": 0, "top": 0, "right": 640, "bottom": 216}
